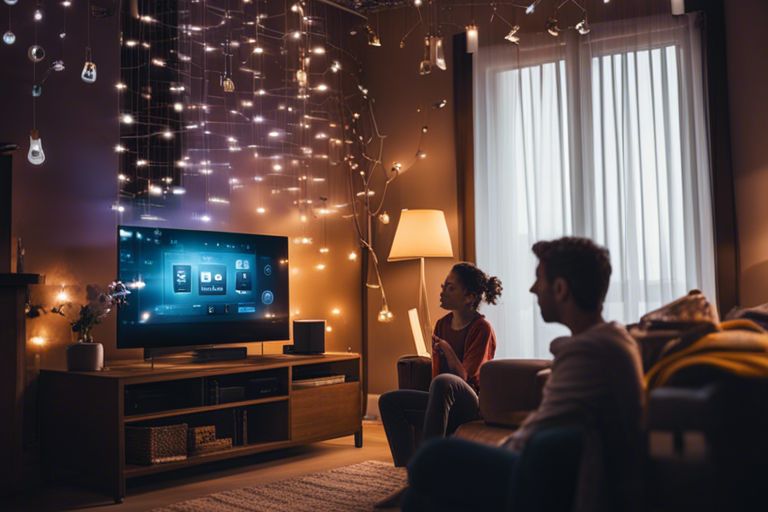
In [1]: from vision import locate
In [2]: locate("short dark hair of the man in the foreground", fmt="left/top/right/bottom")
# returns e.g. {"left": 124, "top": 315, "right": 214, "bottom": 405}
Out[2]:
{"left": 533, "top": 237, "right": 611, "bottom": 311}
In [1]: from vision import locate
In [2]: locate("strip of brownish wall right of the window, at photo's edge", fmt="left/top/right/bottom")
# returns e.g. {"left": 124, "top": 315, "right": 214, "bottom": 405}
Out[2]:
{"left": 724, "top": 0, "right": 768, "bottom": 306}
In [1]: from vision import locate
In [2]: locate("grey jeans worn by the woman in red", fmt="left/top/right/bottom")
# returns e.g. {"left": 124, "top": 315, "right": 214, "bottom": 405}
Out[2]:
{"left": 379, "top": 373, "right": 480, "bottom": 467}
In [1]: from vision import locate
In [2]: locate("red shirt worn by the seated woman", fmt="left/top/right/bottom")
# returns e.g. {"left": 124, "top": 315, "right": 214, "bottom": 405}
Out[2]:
{"left": 432, "top": 313, "right": 496, "bottom": 391}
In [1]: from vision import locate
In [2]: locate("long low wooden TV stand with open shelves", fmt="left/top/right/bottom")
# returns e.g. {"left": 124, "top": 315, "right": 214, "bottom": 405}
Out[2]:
{"left": 40, "top": 353, "right": 363, "bottom": 502}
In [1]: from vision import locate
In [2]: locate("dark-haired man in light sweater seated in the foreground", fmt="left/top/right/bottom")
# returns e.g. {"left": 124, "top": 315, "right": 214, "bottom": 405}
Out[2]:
{"left": 403, "top": 237, "right": 643, "bottom": 510}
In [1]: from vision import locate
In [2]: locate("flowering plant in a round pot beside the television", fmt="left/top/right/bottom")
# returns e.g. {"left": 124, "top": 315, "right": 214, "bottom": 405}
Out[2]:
{"left": 51, "top": 281, "right": 131, "bottom": 371}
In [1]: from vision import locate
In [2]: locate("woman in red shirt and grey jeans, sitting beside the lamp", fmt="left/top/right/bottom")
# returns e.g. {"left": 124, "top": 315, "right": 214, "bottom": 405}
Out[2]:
{"left": 379, "top": 263, "right": 501, "bottom": 467}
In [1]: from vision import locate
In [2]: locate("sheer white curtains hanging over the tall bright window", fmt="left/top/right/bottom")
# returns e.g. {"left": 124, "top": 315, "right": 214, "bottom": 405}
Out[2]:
{"left": 474, "top": 15, "right": 716, "bottom": 357}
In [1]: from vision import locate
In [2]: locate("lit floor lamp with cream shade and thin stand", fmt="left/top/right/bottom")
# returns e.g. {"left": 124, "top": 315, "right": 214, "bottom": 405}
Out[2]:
{"left": 387, "top": 210, "right": 453, "bottom": 344}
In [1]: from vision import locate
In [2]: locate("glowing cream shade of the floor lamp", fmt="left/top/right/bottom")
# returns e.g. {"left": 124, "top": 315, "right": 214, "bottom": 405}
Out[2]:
{"left": 387, "top": 210, "right": 453, "bottom": 261}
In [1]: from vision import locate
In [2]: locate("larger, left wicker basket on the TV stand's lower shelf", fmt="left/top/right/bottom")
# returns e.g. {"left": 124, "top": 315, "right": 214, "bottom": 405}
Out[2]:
{"left": 125, "top": 423, "right": 187, "bottom": 465}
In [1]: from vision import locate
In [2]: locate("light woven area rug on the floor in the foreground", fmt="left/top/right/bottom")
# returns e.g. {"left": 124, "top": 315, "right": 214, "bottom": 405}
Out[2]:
{"left": 153, "top": 460, "right": 407, "bottom": 512}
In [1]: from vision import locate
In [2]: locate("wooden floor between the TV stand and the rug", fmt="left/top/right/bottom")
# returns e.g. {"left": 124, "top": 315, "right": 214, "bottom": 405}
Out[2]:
{"left": 11, "top": 422, "right": 392, "bottom": 512}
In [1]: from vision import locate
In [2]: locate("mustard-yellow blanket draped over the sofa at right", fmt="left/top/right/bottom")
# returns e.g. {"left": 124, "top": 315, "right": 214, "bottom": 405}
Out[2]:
{"left": 645, "top": 319, "right": 768, "bottom": 390}
